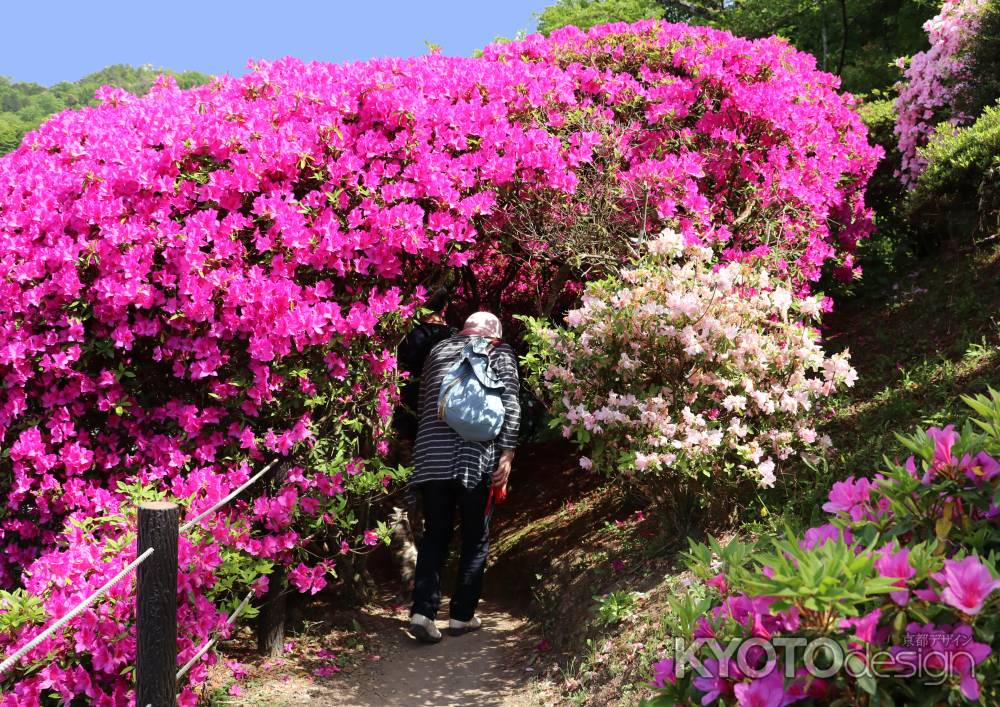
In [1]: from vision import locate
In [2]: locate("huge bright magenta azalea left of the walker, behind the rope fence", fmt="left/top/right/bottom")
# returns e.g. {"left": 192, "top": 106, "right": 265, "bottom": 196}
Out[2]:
{"left": 0, "top": 57, "right": 592, "bottom": 705}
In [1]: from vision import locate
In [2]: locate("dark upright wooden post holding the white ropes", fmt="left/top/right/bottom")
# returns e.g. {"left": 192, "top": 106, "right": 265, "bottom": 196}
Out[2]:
{"left": 135, "top": 501, "right": 180, "bottom": 707}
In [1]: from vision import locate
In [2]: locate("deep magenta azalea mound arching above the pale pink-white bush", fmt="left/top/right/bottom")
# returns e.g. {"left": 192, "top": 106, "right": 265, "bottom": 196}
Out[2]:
{"left": 483, "top": 21, "right": 881, "bottom": 296}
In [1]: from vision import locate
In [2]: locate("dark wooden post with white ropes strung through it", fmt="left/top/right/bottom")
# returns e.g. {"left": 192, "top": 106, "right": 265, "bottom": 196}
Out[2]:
{"left": 0, "top": 459, "right": 278, "bottom": 707}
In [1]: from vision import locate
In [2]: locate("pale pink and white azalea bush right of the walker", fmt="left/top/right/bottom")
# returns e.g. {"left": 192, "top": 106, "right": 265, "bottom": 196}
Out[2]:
{"left": 524, "top": 230, "right": 856, "bottom": 500}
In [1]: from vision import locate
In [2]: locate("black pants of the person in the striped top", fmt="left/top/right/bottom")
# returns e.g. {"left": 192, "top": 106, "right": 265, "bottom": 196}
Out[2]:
{"left": 410, "top": 476, "right": 492, "bottom": 621}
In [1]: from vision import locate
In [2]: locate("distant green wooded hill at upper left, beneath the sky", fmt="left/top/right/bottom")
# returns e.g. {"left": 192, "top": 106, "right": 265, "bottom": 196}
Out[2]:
{"left": 0, "top": 64, "right": 210, "bottom": 155}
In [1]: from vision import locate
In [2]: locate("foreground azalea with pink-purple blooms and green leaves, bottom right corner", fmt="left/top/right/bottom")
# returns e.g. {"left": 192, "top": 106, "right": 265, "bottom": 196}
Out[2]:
{"left": 653, "top": 391, "right": 1000, "bottom": 705}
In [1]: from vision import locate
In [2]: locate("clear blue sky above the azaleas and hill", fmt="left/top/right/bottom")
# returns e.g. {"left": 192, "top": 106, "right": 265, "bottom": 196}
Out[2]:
{"left": 0, "top": 0, "right": 553, "bottom": 85}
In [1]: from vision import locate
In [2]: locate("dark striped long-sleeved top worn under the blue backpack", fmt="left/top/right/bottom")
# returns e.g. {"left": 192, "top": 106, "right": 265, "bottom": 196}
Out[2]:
{"left": 410, "top": 334, "right": 521, "bottom": 488}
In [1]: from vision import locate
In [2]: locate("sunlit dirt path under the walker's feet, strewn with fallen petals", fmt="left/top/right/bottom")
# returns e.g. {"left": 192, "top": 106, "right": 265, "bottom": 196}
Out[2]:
{"left": 211, "top": 448, "right": 584, "bottom": 707}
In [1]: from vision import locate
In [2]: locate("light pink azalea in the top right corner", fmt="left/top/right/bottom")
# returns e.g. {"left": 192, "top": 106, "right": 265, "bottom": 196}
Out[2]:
{"left": 895, "top": 0, "right": 987, "bottom": 185}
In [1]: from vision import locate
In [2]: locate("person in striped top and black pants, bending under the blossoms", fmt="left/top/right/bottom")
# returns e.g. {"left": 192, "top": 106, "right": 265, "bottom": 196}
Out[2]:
{"left": 410, "top": 312, "right": 521, "bottom": 643}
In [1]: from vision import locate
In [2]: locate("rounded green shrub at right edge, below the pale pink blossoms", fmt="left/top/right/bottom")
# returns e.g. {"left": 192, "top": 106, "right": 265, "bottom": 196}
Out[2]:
{"left": 907, "top": 105, "right": 1000, "bottom": 241}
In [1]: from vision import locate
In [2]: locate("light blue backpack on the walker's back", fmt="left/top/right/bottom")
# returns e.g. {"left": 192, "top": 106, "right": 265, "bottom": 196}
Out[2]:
{"left": 438, "top": 336, "right": 505, "bottom": 442}
